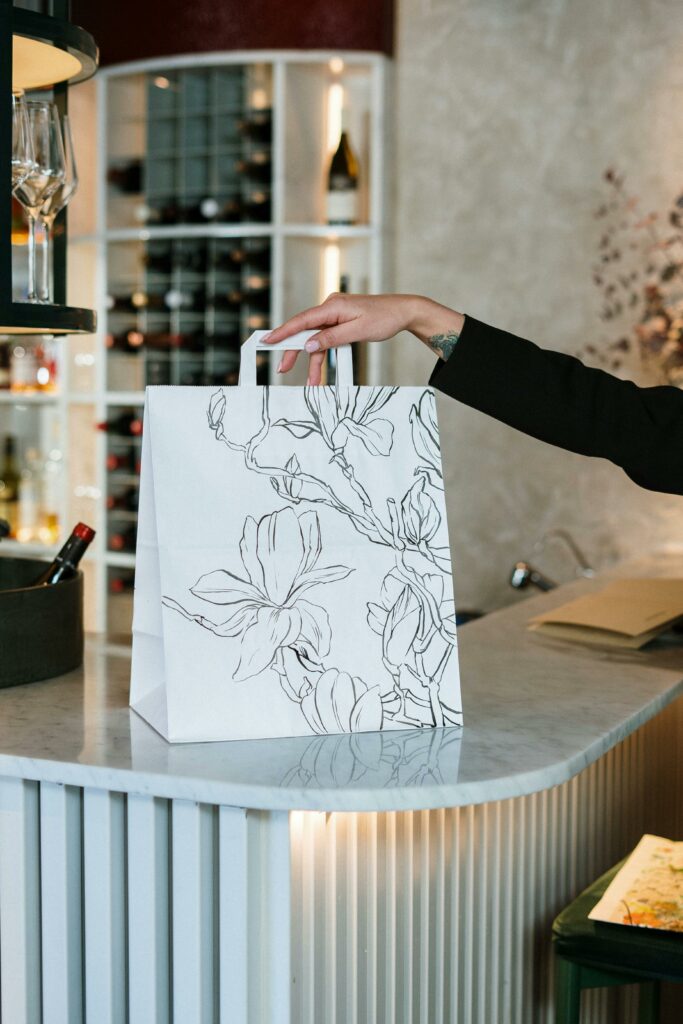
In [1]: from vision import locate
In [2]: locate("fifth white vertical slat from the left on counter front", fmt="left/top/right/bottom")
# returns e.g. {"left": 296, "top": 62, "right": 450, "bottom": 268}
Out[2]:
{"left": 171, "top": 800, "right": 214, "bottom": 1024}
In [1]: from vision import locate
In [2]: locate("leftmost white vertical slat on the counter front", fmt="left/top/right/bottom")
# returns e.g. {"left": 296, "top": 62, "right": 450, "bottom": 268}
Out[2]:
{"left": 0, "top": 778, "right": 41, "bottom": 1024}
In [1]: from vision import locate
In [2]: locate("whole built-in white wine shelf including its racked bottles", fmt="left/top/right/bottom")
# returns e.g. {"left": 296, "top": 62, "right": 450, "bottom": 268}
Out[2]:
{"left": 65, "top": 51, "right": 389, "bottom": 635}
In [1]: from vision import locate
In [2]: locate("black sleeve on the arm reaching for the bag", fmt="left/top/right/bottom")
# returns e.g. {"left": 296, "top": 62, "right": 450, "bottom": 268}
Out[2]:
{"left": 429, "top": 316, "right": 683, "bottom": 495}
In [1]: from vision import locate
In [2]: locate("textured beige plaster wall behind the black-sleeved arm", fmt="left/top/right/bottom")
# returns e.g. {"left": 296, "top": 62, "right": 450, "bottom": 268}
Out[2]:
{"left": 393, "top": 0, "right": 683, "bottom": 608}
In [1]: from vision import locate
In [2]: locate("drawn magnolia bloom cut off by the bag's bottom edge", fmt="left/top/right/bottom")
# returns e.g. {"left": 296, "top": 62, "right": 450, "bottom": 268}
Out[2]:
{"left": 301, "top": 669, "right": 382, "bottom": 733}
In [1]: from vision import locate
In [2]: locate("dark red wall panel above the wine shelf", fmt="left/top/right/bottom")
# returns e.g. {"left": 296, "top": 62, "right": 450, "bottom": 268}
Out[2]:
{"left": 72, "top": 0, "right": 393, "bottom": 65}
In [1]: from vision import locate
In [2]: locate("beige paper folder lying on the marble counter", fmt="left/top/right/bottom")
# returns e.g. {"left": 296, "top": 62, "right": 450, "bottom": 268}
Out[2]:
{"left": 528, "top": 579, "right": 683, "bottom": 649}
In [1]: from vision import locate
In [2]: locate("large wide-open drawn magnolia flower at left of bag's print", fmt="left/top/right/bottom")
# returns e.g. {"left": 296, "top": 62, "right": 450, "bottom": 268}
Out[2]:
{"left": 164, "top": 508, "right": 352, "bottom": 680}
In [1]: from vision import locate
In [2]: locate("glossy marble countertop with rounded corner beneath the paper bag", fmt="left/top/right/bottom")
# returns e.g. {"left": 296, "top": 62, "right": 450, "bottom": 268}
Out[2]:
{"left": 0, "top": 555, "right": 683, "bottom": 811}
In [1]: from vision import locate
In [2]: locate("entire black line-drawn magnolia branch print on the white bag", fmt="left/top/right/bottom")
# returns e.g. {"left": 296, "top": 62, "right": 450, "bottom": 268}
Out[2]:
{"left": 163, "top": 387, "right": 462, "bottom": 734}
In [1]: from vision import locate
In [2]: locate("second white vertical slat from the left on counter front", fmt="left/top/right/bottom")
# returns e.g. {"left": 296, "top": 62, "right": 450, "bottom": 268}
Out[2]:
{"left": 40, "top": 782, "right": 83, "bottom": 1024}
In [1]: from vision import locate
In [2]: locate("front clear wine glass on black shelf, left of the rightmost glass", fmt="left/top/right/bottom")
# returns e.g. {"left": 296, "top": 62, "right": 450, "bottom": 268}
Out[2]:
{"left": 14, "top": 100, "right": 65, "bottom": 302}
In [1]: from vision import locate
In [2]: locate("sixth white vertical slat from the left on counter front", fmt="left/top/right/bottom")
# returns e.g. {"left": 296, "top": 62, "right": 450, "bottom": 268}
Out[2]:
{"left": 218, "top": 807, "right": 249, "bottom": 1024}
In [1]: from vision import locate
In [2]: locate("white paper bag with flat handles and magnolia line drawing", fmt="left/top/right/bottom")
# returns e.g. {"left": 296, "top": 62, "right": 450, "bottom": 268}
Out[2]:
{"left": 130, "top": 332, "right": 462, "bottom": 742}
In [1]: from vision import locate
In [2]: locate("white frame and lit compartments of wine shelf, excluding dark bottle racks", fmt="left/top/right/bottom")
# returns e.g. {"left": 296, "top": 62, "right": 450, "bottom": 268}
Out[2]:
{"left": 63, "top": 51, "right": 389, "bottom": 634}
